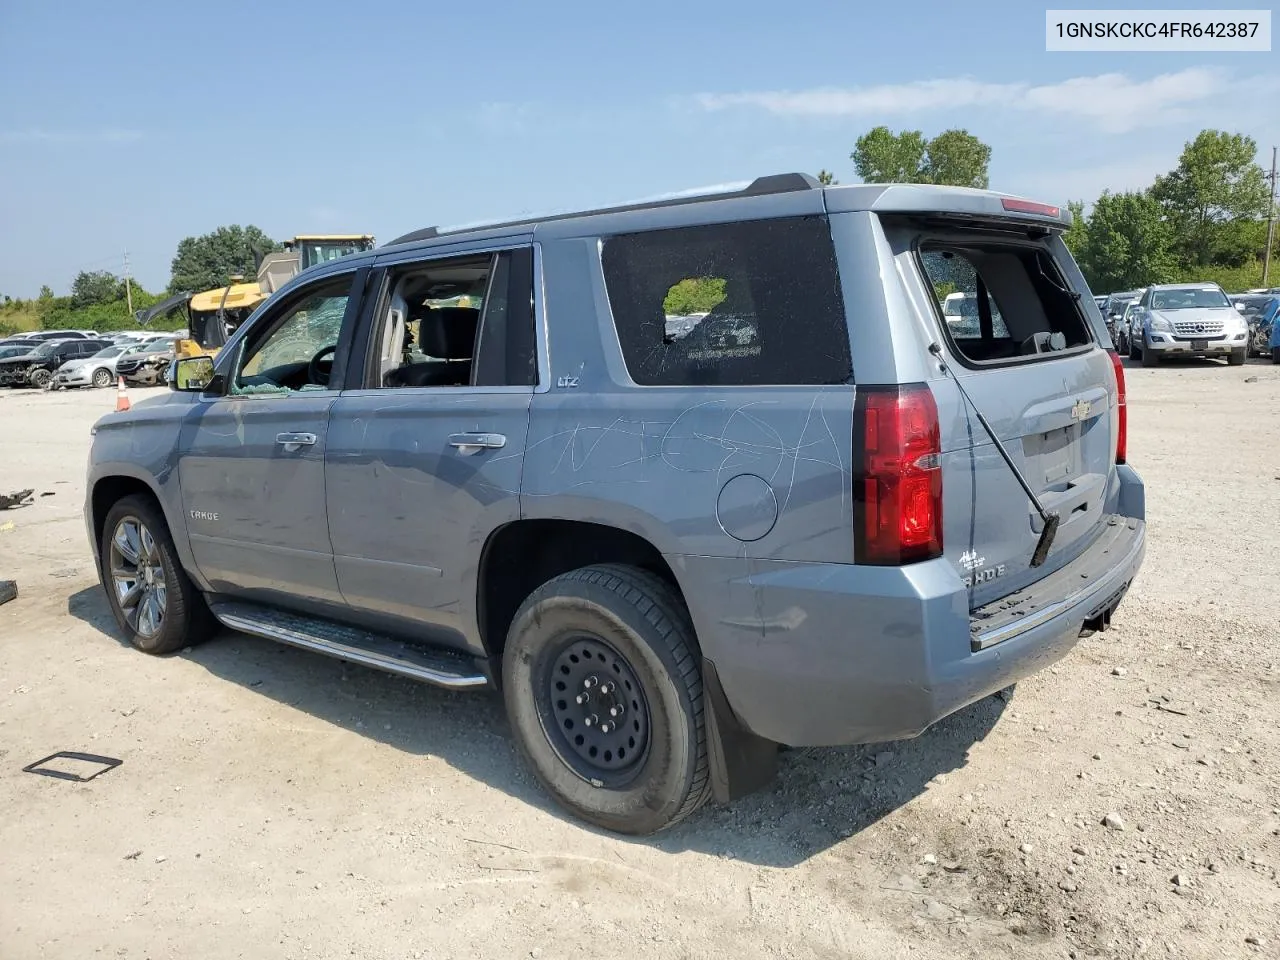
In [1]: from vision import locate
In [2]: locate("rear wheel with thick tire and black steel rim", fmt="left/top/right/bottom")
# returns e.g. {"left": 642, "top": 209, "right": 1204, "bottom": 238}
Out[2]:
{"left": 503, "top": 564, "right": 710, "bottom": 836}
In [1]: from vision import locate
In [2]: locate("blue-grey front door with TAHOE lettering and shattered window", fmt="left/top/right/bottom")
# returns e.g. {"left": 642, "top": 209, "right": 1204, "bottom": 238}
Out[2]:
{"left": 178, "top": 270, "right": 365, "bottom": 608}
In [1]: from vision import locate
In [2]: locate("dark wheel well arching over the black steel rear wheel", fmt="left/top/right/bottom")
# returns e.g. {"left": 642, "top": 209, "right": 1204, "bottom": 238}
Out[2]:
{"left": 476, "top": 520, "right": 680, "bottom": 659}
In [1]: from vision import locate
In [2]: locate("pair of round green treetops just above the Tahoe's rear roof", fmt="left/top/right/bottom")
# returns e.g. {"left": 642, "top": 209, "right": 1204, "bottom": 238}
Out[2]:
{"left": 849, "top": 125, "right": 991, "bottom": 188}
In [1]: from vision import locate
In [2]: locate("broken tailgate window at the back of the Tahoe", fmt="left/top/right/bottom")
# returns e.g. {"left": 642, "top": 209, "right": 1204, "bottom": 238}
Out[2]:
{"left": 920, "top": 241, "right": 1091, "bottom": 364}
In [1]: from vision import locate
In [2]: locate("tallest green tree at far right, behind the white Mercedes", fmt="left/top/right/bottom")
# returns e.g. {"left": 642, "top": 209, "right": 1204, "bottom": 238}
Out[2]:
{"left": 1151, "top": 129, "right": 1268, "bottom": 266}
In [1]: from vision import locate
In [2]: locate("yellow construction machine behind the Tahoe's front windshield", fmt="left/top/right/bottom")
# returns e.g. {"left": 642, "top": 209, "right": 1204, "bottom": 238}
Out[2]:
{"left": 137, "top": 233, "right": 374, "bottom": 357}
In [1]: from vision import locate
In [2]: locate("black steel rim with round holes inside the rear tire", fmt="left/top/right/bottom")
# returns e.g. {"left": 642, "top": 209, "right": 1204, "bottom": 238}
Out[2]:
{"left": 543, "top": 636, "right": 649, "bottom": 786}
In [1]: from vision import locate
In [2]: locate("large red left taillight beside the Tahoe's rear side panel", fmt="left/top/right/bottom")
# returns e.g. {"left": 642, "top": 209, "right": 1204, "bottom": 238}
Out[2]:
{"left": 854, "top": 384, "right": 942, "bottom": 566}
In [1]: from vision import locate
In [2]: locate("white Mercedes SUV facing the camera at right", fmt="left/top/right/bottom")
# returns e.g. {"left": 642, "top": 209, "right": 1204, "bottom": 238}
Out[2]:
{"left": 1130, "top": 283, "right": 1249, "bottom": 366}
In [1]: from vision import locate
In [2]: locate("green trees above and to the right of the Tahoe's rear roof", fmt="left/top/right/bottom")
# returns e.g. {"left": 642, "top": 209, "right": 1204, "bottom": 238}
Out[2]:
{"left": 818, "top": 127, "right": 1280, "bottom": 293}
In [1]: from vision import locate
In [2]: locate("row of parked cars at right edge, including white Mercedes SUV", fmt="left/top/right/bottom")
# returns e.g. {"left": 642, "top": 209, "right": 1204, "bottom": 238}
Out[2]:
{"left": 1096, "top": 283, "right": 1280, "bottom": 366}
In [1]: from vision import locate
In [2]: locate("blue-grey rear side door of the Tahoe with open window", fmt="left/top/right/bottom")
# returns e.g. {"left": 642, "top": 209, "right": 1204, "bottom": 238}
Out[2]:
{"left": 325, "top": 244, "right": 538, "bottom": 646}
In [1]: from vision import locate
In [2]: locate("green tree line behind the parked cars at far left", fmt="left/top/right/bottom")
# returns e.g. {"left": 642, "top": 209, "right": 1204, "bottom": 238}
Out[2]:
{"left": 0, "top": 224, "right": 280, "bottom": 337}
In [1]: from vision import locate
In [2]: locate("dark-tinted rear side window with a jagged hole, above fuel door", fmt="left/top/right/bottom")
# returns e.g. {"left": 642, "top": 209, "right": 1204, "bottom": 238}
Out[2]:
{"left": 603, "top": 216, "right": 852, "bottom": 387}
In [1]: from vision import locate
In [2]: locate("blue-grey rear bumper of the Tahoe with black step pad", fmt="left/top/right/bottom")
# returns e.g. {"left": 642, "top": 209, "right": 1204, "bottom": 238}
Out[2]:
{"left": 671, "top": 471, "right": 1146, "bottom": 746}
